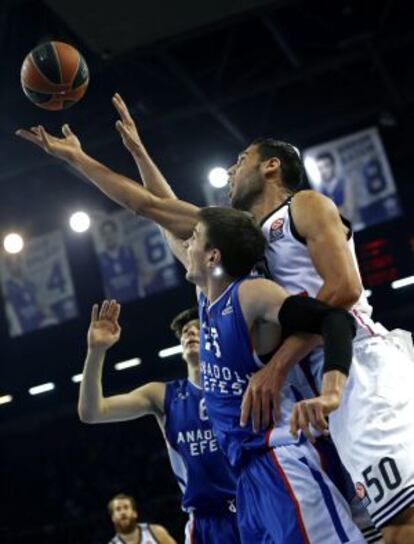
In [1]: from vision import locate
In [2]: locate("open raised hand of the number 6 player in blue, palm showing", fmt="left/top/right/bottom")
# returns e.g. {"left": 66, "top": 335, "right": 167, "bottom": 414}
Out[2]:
{"left": 88, "top": 300, "right": 121, "bottom": 350}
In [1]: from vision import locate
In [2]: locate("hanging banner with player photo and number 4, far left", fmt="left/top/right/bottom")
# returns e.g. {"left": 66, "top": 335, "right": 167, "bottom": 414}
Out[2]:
{"left": 0, "top": 231, "right": 78, "bottom": 337}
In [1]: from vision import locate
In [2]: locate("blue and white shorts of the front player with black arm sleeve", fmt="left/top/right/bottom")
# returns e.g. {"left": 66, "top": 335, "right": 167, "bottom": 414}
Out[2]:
{"left": 237, "top": 441, "right": 365, "bottom": 544}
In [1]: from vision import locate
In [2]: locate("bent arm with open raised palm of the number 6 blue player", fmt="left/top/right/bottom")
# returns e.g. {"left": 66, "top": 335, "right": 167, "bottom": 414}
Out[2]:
{"left": 78, "top": 300, "right": 165, "bottom": 423}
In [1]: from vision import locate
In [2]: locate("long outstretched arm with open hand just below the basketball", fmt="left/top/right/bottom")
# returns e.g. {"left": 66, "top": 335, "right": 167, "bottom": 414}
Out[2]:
{"left": 17, "top": 125, "right": 198, "bottom": 239}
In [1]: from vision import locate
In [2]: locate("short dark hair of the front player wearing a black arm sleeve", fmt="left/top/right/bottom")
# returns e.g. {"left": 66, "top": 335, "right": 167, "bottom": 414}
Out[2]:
{"left": 199, "top": 206, "right": 266, "bottom": 278}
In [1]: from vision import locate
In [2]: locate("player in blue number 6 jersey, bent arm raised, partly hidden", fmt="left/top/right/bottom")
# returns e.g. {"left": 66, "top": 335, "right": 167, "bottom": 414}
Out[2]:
{"left": 79, "top": 301, "right": 239, "bottom": 544}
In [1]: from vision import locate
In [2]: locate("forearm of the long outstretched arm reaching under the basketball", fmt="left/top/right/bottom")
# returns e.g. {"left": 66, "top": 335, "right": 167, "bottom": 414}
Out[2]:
{"left": 69, "top": 151, "right": 151, "bottom": 216}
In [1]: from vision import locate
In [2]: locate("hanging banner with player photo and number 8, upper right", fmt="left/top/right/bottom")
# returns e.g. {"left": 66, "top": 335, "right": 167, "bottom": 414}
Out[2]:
{"left": 303, "top": 128, "right": 401, "bottom": 230}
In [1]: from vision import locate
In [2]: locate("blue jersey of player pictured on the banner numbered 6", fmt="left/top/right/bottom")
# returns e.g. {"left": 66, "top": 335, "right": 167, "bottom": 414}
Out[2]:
{"left": 99, "top": 246, "right": 139, "bottom": 302}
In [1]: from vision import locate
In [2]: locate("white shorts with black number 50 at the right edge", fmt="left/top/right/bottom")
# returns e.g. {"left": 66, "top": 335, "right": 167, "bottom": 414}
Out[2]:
{"left": 329, "top": 329, "right": 414, "bottom": 527}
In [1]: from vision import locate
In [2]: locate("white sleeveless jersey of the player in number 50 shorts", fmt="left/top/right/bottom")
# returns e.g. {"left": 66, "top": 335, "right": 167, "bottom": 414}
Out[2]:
{"left": 261, "top": 198, "right": 386, "bottom": 337}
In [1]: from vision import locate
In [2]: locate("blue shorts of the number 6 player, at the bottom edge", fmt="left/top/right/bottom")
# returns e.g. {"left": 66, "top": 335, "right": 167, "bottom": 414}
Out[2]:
{"left": 185, "top": 507, "right": 239, "bottom": 544}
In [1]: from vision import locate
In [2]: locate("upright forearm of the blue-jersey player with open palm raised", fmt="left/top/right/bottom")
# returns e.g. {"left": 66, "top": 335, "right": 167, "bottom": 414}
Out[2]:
{"left": 78, "top": 349, "right": 106, "bottom": 423}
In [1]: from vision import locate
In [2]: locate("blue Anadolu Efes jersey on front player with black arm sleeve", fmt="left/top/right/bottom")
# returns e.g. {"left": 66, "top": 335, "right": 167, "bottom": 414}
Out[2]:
{"left": 199, "top": 278, "right": 314, "bottom": 465}
